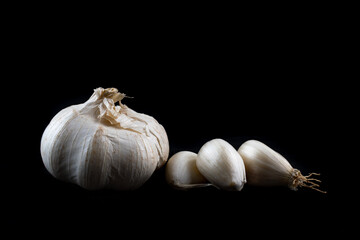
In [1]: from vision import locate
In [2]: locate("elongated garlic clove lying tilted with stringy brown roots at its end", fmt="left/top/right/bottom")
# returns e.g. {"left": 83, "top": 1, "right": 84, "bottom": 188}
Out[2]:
{"left": 238, "top": 140, "right": 323, "bottom": 192}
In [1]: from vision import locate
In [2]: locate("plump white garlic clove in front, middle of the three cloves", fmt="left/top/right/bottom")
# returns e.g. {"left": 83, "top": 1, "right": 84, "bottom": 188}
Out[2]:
{"left": 196, "top": 139, "right": 246, "bottom": 191}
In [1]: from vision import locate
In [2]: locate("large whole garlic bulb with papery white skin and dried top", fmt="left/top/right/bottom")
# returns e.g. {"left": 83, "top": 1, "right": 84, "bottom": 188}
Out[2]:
{"left": 41, "top": 88, "right": 169, "bottom": 190}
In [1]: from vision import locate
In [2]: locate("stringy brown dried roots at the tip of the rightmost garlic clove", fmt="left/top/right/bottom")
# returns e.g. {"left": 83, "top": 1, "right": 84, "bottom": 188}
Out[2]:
{"left": 289, "top": 169, "right": 326, "bottom": 193}
